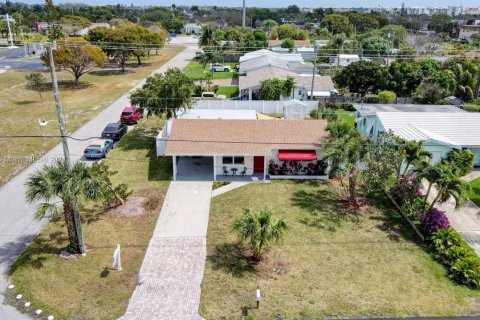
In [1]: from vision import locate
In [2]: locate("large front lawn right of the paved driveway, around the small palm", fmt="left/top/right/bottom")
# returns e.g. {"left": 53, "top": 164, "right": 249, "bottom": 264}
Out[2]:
{"left": 200, "top": 181, "right": 480, "bottom": 319}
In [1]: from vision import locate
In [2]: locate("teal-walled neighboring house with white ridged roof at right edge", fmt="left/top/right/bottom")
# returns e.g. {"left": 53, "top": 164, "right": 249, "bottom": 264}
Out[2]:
{"left": 355, "top": 105, "right": 480, "bottom": 166}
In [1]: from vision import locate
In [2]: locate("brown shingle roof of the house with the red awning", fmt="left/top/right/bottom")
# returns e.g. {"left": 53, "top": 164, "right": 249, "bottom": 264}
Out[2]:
{"left": 165, "top": 119, "right": 327, "bottom": 155}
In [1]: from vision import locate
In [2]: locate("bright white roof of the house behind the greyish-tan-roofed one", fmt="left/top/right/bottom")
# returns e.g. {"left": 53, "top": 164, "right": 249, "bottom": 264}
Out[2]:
{"left": 239, "top": 54, "right": 313, "bottom": 74}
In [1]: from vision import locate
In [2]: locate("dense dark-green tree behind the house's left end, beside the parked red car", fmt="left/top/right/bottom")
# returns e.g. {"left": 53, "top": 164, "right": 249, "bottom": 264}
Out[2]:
{"left": 130, "top": 68, "right": 194, "bottom": 118}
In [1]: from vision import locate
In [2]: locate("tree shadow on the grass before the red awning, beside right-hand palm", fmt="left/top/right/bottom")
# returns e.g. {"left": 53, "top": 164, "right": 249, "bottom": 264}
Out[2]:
{"left": 291, "top": 183, "right": 360, "bottom": 232}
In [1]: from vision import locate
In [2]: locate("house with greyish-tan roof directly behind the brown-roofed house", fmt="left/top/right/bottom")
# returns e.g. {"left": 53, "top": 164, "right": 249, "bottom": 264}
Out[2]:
{"left": 238, "top": 66, "right": 338, "bottom": 100}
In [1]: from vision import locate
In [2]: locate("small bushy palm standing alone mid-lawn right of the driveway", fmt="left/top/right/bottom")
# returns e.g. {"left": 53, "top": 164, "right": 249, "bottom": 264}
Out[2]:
{"left": 233, "top": 209, "right": 287, "bottom": 260}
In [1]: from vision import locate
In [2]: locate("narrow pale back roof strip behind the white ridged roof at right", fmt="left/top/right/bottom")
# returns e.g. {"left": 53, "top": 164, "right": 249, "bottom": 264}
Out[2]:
{"left": 353, "top": 104, "right": 466, "bottom": 115}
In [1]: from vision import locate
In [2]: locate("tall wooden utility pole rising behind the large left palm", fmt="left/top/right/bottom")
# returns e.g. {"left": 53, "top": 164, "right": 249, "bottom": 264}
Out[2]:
{"left": 47, "top": 42, "right": 85, "bottom": 254}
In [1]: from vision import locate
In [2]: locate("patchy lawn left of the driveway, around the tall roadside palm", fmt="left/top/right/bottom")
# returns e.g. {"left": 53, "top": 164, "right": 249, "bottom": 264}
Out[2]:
{"left": 10, "top": 117, "right": 172, "bottom": 320}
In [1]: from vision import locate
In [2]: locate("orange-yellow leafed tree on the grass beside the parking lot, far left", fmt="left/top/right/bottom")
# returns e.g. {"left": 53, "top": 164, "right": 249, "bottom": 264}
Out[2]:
{"left": 41, "top": 38, "right": 107, "bottom": 87}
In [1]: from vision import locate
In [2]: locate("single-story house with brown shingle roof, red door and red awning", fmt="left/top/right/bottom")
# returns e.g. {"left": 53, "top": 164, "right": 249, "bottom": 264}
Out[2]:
{"left": 157, "top": 119, "right": 327, "bottom": 181}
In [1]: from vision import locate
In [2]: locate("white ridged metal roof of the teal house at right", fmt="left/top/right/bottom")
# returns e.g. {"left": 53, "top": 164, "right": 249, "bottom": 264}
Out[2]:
{"left": 377, "top": 112, "right": 480, "bottom": 148}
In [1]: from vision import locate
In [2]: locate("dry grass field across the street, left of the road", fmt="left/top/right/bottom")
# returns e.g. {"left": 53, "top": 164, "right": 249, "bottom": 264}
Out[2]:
{"left": 0, "top": 47, "right": 182, "bottom": 186}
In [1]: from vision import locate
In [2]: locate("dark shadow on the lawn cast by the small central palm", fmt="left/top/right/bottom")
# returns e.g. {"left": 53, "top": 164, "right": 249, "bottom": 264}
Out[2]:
{"left": 207, "top": 242, "right": 256, "bottom": 277}
